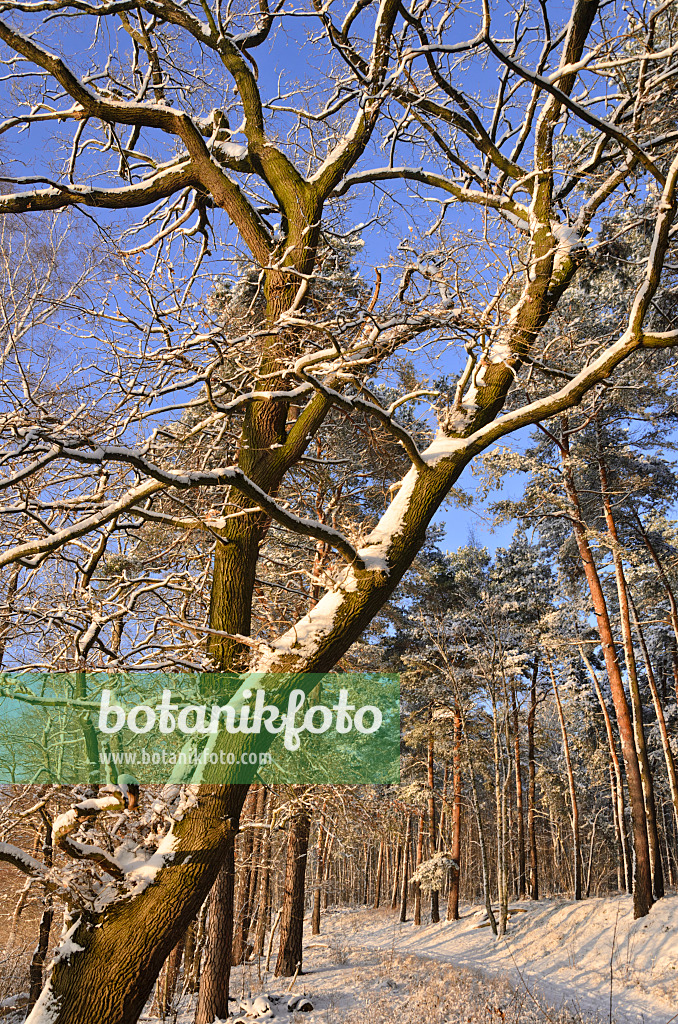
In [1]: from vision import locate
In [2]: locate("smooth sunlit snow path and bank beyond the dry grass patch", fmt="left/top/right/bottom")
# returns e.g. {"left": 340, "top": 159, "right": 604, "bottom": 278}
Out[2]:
{"left": 324, "top": 896, "right": 678, "bottom": 1024}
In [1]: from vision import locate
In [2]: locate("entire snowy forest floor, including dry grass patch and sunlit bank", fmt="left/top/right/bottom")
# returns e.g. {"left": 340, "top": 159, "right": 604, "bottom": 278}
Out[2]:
{"left": 180, "top": 896, "right": 678, "bottom": 1024}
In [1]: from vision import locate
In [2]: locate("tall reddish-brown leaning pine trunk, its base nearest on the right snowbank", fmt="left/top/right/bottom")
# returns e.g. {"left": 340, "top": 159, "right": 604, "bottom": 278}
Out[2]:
{"left": 562, "top": 417, "right": 653, "bottom": 918}
